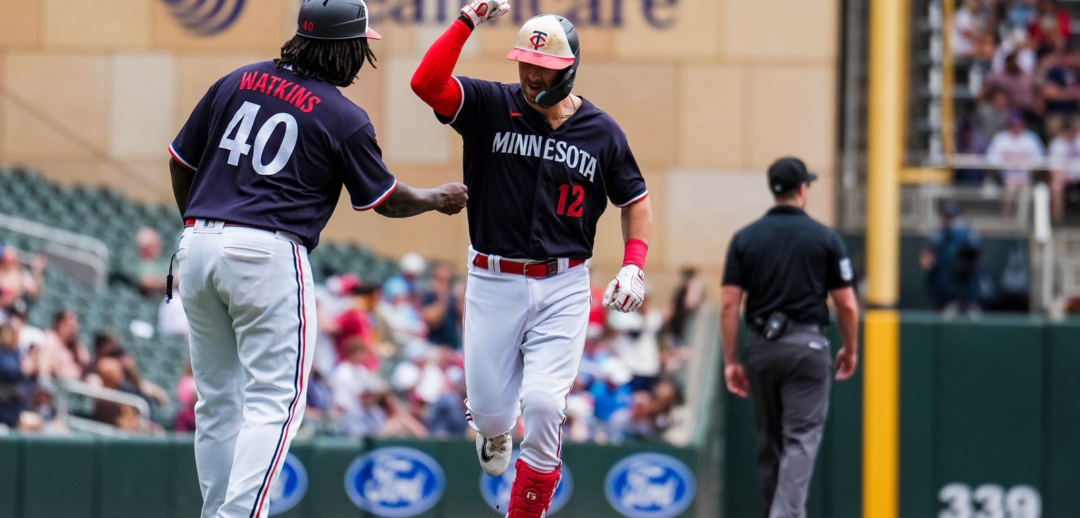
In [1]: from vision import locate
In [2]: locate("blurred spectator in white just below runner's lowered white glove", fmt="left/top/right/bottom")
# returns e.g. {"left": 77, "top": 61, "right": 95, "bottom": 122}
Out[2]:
{"left": 608, "top": 295, "right": 664, "bottom": 392}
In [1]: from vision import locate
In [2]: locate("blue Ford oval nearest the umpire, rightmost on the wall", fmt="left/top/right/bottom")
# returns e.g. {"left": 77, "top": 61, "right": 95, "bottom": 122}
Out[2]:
{"left": 604, "top": 453, "right": 697, "bottom": 518}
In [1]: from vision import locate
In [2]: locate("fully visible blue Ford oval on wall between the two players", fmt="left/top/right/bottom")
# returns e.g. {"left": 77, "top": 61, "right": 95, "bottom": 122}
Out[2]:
{"left": 345, "top": 447, "right": 446, "bottom": 518}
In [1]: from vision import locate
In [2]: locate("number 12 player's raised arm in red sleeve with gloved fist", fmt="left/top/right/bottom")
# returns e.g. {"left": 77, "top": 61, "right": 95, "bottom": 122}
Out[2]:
{"left": 411, "top": 0, "right": 510, "bottom": 117}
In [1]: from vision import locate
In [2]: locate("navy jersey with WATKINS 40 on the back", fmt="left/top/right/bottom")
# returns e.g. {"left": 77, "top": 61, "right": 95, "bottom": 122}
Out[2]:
{"left": 170, "top": 62, "right": 397, "bottom": 249}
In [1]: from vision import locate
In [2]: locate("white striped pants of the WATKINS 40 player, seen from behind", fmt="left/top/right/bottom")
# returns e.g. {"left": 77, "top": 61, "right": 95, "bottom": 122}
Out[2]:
{"left": 177, "top": 220, "right": 318, "bottom": 518}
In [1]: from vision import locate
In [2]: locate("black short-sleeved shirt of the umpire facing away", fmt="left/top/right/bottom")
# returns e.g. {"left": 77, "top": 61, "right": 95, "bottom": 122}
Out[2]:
{"left": 724, "top": 206, "right": 853, "bottom": 326}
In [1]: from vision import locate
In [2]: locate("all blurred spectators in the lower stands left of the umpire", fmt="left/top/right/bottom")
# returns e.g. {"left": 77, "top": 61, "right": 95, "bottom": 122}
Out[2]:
{"left": 0, "top": 224, "right": 704, "bottom": 442}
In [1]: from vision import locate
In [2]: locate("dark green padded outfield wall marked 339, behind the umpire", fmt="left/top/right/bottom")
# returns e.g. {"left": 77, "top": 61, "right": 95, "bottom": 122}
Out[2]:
{"left": 723, "top": 313, "right": 1080, "bottom": 518}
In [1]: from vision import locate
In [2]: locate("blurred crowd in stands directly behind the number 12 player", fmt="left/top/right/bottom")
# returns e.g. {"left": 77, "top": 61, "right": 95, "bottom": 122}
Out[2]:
{"left": 291, "top": 254, "right": 703, "bottom": 442}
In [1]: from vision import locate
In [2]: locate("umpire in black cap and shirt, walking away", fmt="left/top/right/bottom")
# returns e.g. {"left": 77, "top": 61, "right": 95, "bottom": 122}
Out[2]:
{"left": 720, "top": 158, "right": 859, "bottom": 518}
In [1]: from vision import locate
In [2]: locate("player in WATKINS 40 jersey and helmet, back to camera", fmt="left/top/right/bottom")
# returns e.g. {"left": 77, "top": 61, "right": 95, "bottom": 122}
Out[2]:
{"left": 168, "top": 0, "right": 468, "bottom": 518}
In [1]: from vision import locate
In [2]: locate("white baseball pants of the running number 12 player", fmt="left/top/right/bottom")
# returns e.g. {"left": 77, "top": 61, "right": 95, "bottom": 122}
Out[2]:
{"left": 463, "top": 250, "right": 592, "bottom": 472}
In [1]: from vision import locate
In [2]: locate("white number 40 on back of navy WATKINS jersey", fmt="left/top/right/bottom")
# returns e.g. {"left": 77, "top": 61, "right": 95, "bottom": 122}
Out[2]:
{"left": 218, "top": 103, "right": 297, "bottom": 176}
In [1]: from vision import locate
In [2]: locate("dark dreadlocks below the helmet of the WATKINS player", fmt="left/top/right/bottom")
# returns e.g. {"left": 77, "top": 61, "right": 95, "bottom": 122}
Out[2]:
{"left": 274, "top": 36, "right": 378, "bottom": 87}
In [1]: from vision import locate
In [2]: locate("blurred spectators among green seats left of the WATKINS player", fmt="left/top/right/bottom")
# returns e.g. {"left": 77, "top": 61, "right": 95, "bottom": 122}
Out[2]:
{"left": 0, "top": 229, "right": 179, "bottom": 433}
